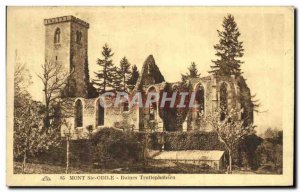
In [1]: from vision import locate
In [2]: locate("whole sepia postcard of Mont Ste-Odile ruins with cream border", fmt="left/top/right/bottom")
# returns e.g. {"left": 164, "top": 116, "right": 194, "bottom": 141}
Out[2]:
{"left": 6, "top": 6, "right": 295, "bottom": 186}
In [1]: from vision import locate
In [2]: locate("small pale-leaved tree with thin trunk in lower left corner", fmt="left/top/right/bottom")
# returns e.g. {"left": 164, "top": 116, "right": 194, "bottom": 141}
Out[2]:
{"left": 14, "top": 100, "right": 59, "bottom": 173}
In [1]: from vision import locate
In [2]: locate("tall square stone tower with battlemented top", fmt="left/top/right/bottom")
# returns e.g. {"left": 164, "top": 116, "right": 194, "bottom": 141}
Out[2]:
{"left": 44, "top": 16, "right": 89, "bottom": 97}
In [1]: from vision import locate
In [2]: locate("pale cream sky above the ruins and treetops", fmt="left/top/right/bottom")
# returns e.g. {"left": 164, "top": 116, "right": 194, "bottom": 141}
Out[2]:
{"left": 7, "top": 7, "right": 287, "bottom": 134}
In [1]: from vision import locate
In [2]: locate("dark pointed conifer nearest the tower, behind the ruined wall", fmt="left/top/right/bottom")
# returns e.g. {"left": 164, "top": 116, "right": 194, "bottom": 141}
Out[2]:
{"left": 93, "top": 44, "right": 116, "bottom": 93}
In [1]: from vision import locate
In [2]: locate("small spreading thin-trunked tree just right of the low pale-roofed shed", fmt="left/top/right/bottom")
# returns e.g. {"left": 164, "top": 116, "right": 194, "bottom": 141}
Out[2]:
{"left": 203, "top": 110, "right": 254, "bottom": 173}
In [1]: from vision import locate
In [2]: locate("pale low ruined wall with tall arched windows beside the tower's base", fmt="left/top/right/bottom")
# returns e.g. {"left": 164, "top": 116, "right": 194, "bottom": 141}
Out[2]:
{"left": 61, "top": 97, "right": 139, "bottom": 139}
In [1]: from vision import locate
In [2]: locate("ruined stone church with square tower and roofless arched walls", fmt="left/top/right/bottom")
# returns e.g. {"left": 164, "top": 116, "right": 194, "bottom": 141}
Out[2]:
{"left": 44, "top": 16, "right": 253, "bottom": 139}
